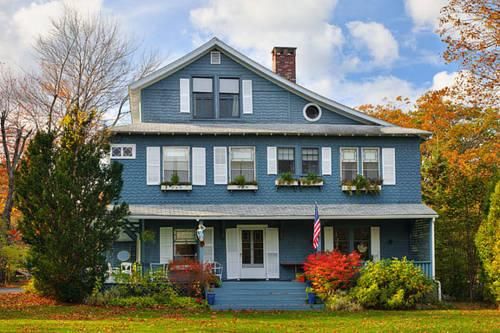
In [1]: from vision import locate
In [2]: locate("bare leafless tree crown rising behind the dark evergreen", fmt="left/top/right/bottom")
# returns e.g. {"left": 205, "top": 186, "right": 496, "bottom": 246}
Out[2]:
{"left": 27, "top": 7, "right": 160, "bottom": 130}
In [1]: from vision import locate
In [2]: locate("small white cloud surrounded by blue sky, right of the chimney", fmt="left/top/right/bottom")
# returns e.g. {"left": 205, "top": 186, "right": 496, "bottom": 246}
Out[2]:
{"left": 347, "top": 21, "right": 399, "bottom": 66}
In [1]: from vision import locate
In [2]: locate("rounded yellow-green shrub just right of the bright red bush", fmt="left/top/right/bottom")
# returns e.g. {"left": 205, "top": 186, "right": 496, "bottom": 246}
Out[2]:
{"left": 351, "top": 258, "right": 432, "bottom": 309}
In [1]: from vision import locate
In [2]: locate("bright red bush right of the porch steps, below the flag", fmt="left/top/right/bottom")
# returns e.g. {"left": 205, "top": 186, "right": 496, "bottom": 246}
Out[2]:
{"left": 304, "top": 251, "right": 361, "bottom": 299}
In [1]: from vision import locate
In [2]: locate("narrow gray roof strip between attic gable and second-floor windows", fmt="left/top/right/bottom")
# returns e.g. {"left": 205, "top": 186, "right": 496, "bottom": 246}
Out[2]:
{"left": 111, "top": 123, "right": 431, "bottom": 137}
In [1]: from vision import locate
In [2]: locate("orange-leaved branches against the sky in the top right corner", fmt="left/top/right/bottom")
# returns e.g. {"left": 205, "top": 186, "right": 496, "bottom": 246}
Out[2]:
{"left": 439, "top": 0, "right": 500, "bottom": 107}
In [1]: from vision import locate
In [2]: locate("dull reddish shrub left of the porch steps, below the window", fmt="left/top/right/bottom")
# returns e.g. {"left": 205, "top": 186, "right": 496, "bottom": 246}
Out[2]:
{"left": 168, "top": 259, "right": 217, "bottom": 297}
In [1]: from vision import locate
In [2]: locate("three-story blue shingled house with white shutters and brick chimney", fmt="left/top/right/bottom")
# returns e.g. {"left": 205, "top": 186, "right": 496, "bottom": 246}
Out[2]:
{"left": 109, "top": 38, "right": 436, "bottom": 308}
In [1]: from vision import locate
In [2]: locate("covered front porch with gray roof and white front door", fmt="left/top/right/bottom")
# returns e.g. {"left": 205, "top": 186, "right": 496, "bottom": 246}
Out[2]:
{"left": 109, "top": 204, "right": 435, "bottom": 281}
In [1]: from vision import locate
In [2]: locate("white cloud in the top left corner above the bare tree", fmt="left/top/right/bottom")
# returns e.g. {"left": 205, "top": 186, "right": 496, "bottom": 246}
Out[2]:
{"left": 0, "top": 0, "right": 102, "bottom": 69}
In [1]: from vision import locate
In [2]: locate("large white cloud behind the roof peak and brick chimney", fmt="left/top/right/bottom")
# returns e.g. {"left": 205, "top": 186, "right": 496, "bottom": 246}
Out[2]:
{"left": 190, "top": 0, "right": 344, "bottom": 83}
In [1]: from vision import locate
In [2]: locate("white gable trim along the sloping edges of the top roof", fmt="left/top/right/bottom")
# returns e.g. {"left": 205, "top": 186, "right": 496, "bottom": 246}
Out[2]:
{"left": 129, "top": 37, "right": 394, "bottom": 126}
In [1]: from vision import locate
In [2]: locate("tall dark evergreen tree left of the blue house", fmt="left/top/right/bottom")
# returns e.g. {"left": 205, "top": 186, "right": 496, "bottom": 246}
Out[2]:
{"left": 16, "top": 109, "right": 128, "bottom": 302}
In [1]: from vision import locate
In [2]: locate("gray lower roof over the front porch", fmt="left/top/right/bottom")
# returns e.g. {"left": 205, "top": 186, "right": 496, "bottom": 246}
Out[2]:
{"left": 129, "top": 204, "right": 437, "bottom": 220}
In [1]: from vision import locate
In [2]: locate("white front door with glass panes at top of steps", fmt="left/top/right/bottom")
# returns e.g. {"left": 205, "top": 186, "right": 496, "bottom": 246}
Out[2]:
{"left": 240, "top": 228, "right": 266, "bottom": 279}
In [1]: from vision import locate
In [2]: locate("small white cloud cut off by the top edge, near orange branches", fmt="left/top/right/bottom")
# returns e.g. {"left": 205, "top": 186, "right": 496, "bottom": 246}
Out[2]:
{"left": 405, "top": 0, "right": 448, "bottom": 30}
